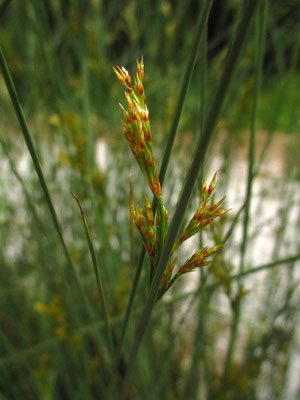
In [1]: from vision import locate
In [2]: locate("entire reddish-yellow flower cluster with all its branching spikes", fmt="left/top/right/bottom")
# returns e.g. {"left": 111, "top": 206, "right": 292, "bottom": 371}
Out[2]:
{"left": 114, "top": 58, "right": 228, "bottom": 300}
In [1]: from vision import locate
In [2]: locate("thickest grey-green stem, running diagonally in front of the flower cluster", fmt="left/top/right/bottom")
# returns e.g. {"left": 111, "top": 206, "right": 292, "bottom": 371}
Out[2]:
{"left": 122, "top": 0, "right": 258, "bottom": 398}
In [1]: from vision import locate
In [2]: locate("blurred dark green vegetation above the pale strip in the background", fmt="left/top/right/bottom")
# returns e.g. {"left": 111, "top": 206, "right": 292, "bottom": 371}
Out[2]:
{"left": 0, "top": 0, "right": 300, "bottom": 132}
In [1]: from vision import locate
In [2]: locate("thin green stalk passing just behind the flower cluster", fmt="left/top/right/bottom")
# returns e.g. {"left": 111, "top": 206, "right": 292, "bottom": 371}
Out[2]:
{"left": 112, "top": 1, "right": 212, "bottom": 372}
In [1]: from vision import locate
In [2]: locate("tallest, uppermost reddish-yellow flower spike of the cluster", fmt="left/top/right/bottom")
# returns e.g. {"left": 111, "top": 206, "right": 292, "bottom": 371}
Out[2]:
{"left": 114, "top": 58, "right": 161, "bottom": 197}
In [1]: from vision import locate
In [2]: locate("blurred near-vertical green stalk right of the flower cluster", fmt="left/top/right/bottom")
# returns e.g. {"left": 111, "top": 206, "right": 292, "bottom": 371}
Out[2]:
{"left": 220, "top": 0, "right": 267, "bottom": 392}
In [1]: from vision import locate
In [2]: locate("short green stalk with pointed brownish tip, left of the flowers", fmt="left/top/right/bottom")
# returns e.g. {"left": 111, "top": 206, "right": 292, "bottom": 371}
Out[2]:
{"left": 72, "top": 193, "right": 113, "bottom": 349}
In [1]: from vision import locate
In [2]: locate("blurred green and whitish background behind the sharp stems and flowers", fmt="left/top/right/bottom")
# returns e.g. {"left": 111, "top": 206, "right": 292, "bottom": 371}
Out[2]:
{"left": 0, "top": 0, "right": 300, "bottom": 400}
